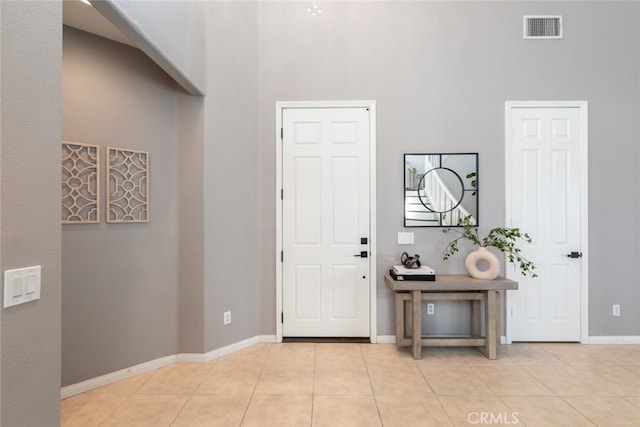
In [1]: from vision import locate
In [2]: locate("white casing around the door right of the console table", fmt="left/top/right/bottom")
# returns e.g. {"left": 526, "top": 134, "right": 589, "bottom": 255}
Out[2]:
{"left": 505, "top": 101, "right": 589, "bottom": 344}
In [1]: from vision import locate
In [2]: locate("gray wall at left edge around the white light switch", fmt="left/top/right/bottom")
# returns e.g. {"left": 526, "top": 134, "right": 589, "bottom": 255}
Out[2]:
{"left": 0, "top": 1, "right": 62, "bottom": 427}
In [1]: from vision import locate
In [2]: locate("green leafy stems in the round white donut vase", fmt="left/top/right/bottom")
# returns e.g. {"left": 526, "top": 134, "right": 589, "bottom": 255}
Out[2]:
{"left": 442, "top": 215, "right": 538, "bottom": 277}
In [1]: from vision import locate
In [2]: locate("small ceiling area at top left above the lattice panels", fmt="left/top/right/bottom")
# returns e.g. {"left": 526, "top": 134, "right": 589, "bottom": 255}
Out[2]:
{"left": 62, "top": 0, "right": 137, "bottom": 47}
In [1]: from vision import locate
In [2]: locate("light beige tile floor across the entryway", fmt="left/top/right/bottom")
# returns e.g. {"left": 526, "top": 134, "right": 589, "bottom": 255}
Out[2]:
{"left": 62, "top": 343, "right": 640, "bottom": 427}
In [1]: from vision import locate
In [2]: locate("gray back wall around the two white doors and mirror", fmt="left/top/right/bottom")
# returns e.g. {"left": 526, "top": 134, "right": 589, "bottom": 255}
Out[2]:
{"left": 255, "top": 2, "right": 640, "bottom": 336}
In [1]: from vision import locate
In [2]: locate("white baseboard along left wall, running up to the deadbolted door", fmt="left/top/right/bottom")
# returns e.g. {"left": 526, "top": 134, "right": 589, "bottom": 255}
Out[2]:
{"left": 60, "top": 335, "right": 276, "bottom": 399}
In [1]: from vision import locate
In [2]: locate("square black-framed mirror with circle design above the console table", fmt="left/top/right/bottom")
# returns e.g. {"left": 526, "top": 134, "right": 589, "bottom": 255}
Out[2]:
{"left": 404, "top": 153, "right": 479, "bottom": 227}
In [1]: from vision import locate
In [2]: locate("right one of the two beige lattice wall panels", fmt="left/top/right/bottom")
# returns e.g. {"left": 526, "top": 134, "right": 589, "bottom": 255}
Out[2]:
{"left": 107, "top": 147, "right": 149, "bottom": 223}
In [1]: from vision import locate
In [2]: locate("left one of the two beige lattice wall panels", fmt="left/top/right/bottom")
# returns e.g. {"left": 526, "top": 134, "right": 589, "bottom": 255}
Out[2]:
{"left": 62, "top": 141, "right": 100, "bottom": 224}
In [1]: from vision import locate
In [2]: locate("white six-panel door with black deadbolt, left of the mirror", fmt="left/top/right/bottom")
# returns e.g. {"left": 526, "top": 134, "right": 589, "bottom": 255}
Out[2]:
{"left": 282, "top": 108, "right": 370, "bottom": 337}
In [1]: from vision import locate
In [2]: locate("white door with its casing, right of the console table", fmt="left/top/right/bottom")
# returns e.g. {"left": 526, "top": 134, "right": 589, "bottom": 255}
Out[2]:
{"left": 506, "top": 105, "right": 587, "bottom": 341}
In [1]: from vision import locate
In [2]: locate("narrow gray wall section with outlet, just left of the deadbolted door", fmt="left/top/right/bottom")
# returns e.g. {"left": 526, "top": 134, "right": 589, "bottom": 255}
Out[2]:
{"left": 204, "top": 2, "right": 260, "bottom": 351}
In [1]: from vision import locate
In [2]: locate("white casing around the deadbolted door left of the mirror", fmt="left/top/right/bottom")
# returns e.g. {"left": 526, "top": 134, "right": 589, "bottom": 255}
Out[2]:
{"left": 275, "top": 101, "right": 378, "bottom": 343}
